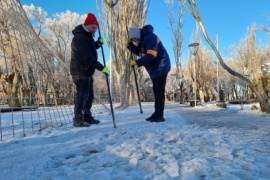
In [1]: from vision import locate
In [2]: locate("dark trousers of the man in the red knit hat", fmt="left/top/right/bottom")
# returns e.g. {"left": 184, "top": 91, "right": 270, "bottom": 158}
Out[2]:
{"left": 72, "top": 75, "right": 94, "bottom": 118}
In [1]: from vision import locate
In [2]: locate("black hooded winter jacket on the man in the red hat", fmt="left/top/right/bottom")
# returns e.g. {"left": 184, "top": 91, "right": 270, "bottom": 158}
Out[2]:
{"left": 70, "top": 25, "right": 104, "bottom": 76}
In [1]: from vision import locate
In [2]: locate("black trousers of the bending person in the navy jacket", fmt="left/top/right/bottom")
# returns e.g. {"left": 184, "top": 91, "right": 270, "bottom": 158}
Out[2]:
{"left": 152, "top": 74, "right": 167, "bottom": 118}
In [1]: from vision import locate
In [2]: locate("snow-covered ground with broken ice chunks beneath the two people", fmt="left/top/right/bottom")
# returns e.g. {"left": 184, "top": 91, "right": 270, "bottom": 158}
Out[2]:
{"left": 0, "top": 103, "right": 270, "bottom": 180}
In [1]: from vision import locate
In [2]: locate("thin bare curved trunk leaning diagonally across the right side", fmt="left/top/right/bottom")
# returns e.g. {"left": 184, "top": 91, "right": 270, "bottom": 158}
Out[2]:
{"left": 179, "top": 0, "right": 270, "bottom": 113}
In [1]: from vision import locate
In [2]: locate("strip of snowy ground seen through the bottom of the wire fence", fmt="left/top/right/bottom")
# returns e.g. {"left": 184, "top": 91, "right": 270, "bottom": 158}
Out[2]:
{"left": 0, "top": 103, "right": 110, "bottom": 141}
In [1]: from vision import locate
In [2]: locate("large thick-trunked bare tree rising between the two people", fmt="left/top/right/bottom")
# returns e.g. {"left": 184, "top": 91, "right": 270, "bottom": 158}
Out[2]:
{"left": 96, "top": 0, "right": 150, "bottom": 108}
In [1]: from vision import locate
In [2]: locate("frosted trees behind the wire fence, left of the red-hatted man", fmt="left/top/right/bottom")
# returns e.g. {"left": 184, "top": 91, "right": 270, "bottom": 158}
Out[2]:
{"left": 0, "top": 0, "right": 86, "bottom": 107}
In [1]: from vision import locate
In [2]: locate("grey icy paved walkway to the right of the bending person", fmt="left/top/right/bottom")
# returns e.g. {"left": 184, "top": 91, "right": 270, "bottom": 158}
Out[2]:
{"left": 166, "top": 103, "right": 270, "bottom": 133}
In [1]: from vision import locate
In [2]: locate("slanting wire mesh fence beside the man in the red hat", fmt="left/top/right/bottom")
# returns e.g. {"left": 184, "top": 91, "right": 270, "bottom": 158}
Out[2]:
{"left": 0, "top": 0, "right": 110, "bottom": 141}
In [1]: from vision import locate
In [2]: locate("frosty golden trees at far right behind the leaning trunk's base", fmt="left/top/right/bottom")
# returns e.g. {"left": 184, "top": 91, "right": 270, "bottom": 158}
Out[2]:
{"left": 230, "top": 24, "right": 270, "bottom": 102}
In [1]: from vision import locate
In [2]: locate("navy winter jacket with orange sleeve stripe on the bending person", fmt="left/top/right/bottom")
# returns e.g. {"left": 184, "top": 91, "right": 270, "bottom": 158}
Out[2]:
{"left": 130, "top": 25, "right": 171, "bottom": 79}
